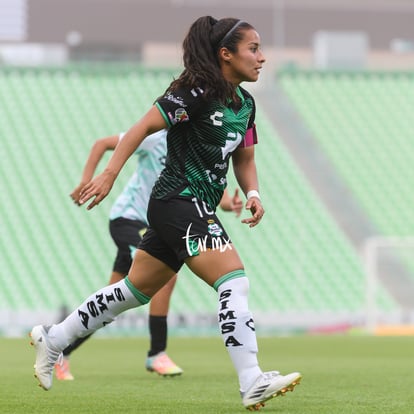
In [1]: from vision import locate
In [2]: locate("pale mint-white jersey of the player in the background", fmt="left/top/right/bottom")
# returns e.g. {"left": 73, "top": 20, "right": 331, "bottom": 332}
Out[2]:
{"left": 109, "top": 130, "right": 167, "bottom": 223}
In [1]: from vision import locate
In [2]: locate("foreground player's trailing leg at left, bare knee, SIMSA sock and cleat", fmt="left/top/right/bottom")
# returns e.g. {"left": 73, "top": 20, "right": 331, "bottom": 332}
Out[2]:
{"left": 31, "top": 250, "right": 175, "bottom": 390}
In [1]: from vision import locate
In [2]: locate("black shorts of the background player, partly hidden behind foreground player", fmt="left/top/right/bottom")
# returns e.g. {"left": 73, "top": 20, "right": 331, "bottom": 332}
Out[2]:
{"left": 109, "top": 217, "right": 148, "bottom": 274}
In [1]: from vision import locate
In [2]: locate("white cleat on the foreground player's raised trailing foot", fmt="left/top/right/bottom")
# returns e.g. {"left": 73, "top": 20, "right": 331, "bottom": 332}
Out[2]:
{"left": 29, "top": 325, "right": 62, "bottom": 391}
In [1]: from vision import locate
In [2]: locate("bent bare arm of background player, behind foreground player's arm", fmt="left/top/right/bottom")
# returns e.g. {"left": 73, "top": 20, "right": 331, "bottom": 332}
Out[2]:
{"left": 70, "top": 135, "right": 119, "bottom": 205}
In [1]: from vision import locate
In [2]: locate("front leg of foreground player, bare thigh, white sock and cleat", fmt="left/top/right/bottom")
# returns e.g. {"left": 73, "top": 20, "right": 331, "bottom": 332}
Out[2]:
{"left": 186, "top": 246, "right": 301, "bottom": 410}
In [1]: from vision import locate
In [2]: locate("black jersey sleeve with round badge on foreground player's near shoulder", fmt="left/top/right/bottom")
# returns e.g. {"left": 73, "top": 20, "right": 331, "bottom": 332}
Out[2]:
{"left": 155, "top": 88, "right": 203, "bottom": 127}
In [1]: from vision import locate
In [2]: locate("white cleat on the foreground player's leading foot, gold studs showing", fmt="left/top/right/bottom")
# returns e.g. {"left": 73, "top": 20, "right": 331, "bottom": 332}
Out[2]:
{"left": 242, "top": 371, "right": 302, "bottom": 411}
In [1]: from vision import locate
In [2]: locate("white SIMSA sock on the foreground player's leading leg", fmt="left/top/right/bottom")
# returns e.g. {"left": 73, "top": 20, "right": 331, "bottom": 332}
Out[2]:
{"left": 217, "top": 276, "right": 262, "bottom": 392}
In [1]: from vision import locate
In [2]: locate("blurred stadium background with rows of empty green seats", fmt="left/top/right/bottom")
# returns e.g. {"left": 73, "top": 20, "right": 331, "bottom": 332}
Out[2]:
{"left": 0, "top": 0, "right": 414, "bottom": 336}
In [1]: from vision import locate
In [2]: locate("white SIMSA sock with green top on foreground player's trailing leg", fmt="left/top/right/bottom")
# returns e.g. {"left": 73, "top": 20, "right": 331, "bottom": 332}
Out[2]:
{"left": 48, "top": 277, "right": 150, "bottom": 350}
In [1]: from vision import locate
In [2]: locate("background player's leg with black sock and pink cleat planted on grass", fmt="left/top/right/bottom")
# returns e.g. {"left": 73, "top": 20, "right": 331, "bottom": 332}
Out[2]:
{"left": 145, "top": 276, "right": 183, "bottom": 376}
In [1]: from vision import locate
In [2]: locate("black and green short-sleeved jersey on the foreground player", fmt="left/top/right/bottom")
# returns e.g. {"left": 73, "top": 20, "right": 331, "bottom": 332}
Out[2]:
{"left": 152, "top": 88, "right": 257, "bottom": 210}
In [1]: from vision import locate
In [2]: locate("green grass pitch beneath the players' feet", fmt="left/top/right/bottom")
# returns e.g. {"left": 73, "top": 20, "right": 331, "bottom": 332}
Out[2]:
{"left": 0, "top": 335, "right": 414, "bottom": 414}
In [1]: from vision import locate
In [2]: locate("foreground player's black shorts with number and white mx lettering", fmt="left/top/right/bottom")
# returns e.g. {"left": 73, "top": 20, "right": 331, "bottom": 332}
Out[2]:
{"left": 139, "top": 197, "right": 231, "bottom": 272}
